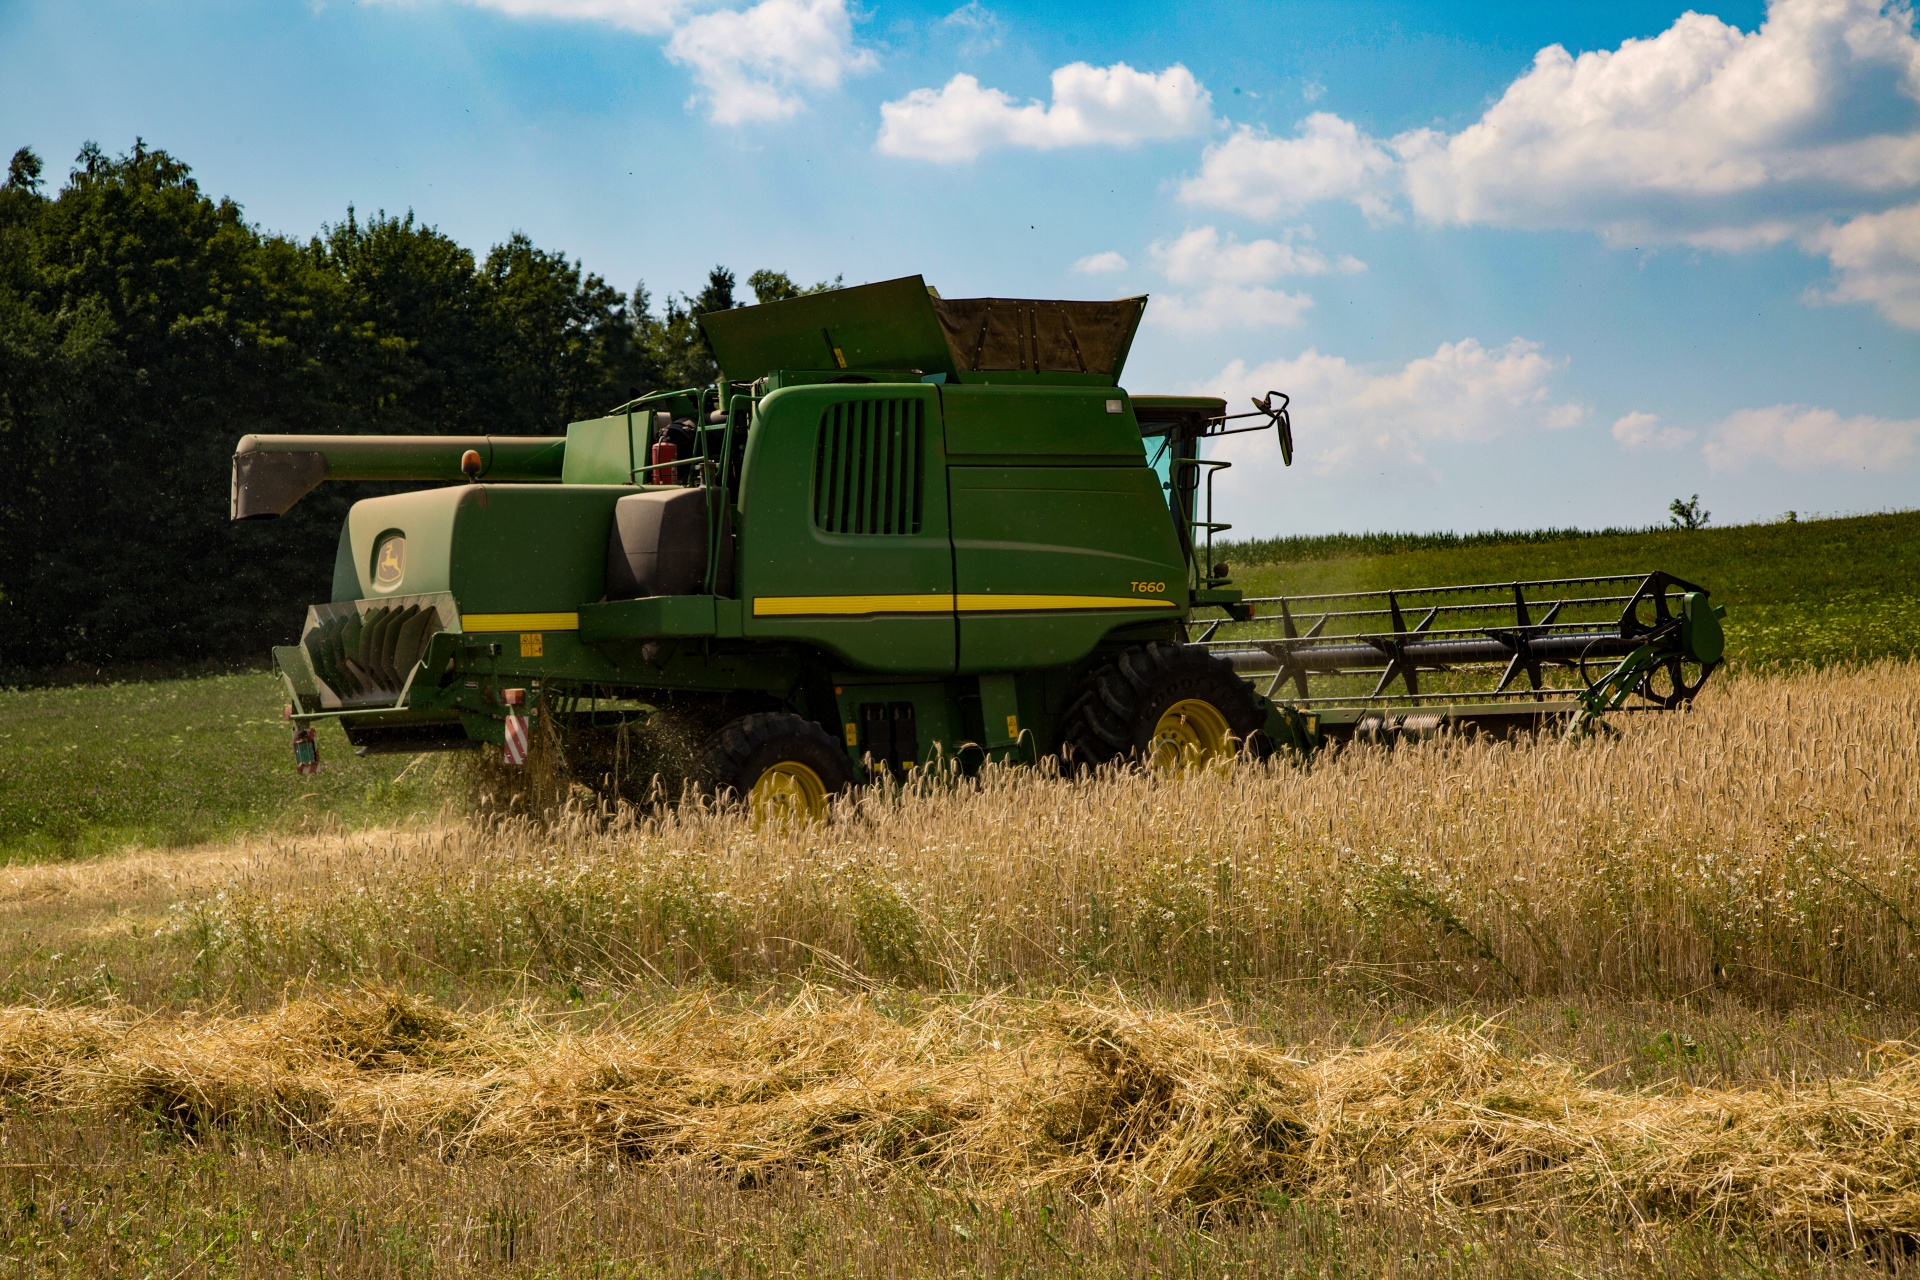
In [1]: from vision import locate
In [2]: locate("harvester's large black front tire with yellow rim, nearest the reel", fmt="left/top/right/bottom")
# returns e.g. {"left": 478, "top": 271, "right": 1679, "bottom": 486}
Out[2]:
{"left": 1060, "top": 641, "right": 1265, "bottom": 771}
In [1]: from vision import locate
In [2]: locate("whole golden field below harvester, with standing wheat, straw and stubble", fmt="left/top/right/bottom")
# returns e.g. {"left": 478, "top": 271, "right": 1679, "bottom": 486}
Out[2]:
{"left": 0, "top": 662, "right": 1920, "bottom": 1276}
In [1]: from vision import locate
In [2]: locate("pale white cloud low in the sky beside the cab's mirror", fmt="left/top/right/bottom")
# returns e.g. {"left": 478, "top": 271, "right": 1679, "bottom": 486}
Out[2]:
{"left": 1204, "top": 338, "right": 1586, "bottom": 475}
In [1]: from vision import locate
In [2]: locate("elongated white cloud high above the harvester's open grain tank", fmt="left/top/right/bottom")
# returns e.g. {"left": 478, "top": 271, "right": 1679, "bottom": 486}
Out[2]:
{"left": 876, "top": 61, "right": 1212, "bottom": 163}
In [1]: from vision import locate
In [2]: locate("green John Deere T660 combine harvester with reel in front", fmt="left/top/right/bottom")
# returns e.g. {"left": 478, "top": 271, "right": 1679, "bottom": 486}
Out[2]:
{"left": 232, "top": 276, "right": 1722, "bottom": 816}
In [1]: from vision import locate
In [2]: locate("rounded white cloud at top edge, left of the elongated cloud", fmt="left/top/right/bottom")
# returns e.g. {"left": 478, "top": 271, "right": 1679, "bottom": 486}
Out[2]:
{"left": 666, "top": 0, "right": 874, "bottom": 125}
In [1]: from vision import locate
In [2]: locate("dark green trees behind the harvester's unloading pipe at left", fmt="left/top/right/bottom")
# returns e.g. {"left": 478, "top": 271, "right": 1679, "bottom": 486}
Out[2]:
{"left": 0, "top": 142, "right": 837, "bottom": 681}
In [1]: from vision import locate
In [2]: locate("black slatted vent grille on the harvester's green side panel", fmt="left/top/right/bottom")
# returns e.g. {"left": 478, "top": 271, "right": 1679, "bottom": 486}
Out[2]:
{"left": 814, "top": 399, "right": 927, "bottom": 533}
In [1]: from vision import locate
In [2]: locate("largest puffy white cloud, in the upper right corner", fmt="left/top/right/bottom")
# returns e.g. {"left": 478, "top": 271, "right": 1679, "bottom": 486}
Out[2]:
{"left": 1396, "top": 0, "right": 1920, "bottom": 248}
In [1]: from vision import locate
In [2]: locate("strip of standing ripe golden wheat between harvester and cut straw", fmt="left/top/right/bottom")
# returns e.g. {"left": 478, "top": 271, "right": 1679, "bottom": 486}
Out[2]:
{"left": 171, "top": 664, "right": 1920, "bottom": 1007}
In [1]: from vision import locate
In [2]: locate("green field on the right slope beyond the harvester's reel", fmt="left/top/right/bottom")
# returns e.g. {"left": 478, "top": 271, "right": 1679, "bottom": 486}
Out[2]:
{"left": 1215, "top": 512, "right": 1920, "bottom": 666}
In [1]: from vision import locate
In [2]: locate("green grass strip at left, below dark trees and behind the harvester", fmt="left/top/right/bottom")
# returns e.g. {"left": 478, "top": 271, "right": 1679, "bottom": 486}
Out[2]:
{"left": 0, "top": 674, "right": 447, "bottom": 862}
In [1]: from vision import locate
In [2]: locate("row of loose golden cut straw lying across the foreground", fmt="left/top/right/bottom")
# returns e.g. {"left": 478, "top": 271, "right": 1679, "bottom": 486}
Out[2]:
{"left": 11, "top": 988, "right": 1920, "bottom": 1242}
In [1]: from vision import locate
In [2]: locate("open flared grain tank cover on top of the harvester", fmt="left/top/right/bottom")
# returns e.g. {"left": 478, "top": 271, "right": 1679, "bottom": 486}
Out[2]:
{"left": 701, "top": 276, "right": 1146, "bottom": 386}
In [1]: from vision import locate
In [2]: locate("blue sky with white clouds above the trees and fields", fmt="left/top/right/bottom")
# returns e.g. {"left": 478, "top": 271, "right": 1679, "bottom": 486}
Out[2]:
{"left": 0, "top": 0, "right": 1920, "bottom": 533}
